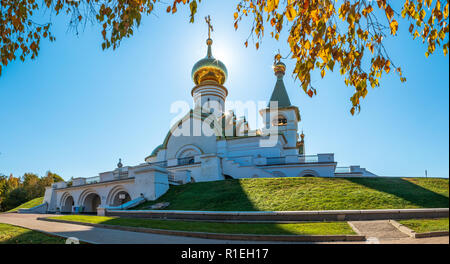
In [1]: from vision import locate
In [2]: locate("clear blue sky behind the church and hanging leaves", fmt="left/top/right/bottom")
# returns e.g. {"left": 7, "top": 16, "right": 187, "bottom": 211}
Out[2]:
{"left": 0, "top": 0, "right": 449, "bottom": 179}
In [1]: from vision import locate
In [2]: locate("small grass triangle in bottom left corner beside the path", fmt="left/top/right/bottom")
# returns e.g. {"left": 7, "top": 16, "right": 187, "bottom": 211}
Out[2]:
{"left": 0, "top": 223, "right": 65, "bottom": 244}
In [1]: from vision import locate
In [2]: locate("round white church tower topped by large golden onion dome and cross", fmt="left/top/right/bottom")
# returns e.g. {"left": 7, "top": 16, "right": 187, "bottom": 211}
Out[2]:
{"left": 191, "top": 17, "right": 228, "bottom": 116}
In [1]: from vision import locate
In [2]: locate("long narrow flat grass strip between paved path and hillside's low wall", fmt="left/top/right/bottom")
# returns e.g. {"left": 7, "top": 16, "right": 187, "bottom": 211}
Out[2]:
{"left": 50, "top": 215, "right": 355, "bottom": 235}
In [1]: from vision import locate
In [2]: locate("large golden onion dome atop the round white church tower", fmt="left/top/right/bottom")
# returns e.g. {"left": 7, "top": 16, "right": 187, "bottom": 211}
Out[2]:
{"left": 192, "top": 38, "right": 228, "bottom": 85}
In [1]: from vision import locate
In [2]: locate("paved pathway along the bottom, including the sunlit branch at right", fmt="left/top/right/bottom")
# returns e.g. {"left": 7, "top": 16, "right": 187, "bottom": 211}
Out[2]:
{"left": 0, "top": 213, "right": 449, "bottom": 244}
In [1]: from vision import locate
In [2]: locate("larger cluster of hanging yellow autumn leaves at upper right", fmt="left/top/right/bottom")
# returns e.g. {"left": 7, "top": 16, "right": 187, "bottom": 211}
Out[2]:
{"left": 230, "top": 0, "right": 449, "bottom": 115}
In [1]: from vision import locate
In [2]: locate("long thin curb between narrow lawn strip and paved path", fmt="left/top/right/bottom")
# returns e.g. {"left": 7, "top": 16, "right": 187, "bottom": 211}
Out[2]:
{"left": 37, "top": 217, "right": 366, "bottom": 242}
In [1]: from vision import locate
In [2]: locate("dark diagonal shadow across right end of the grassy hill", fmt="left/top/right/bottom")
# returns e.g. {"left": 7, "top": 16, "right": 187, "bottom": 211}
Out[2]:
{"left": 347, "top": 177, "right": 449, "bottom": 208}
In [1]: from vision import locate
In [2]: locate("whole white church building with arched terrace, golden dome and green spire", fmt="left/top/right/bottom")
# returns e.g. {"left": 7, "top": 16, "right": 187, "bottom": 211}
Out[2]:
{"left": 37, "top": 32, "right": 376, "bottom": 216}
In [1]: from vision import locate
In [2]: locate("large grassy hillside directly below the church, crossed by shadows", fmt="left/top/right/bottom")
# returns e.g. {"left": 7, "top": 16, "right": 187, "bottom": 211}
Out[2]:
{"left": 135, "top": 178, "right": 449, "bottom": 211}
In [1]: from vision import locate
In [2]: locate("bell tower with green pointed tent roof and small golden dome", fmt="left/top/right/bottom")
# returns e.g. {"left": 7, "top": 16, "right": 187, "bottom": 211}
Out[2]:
{"left": 260, "top": 59, "right": 301, "bottom": 155}
